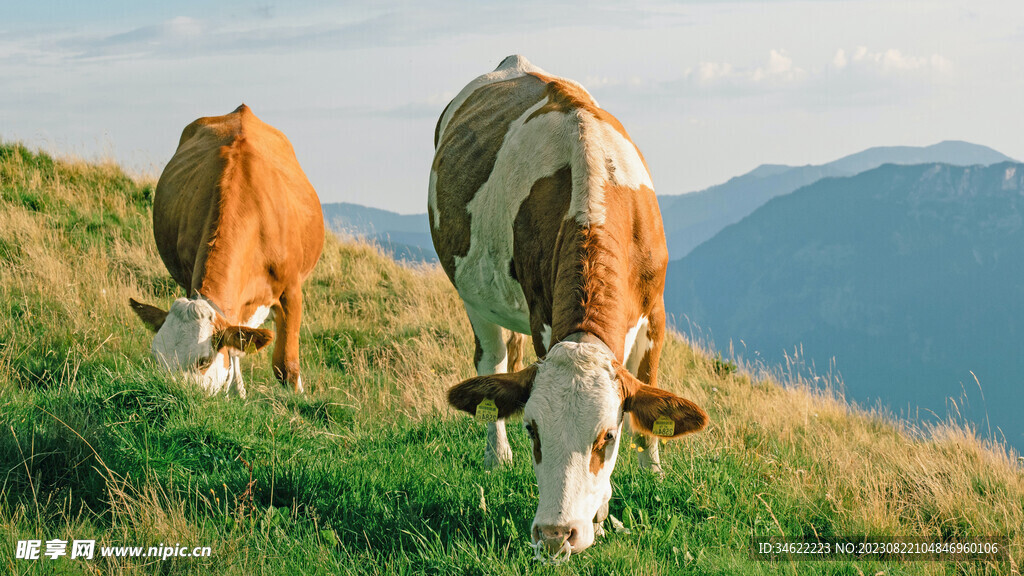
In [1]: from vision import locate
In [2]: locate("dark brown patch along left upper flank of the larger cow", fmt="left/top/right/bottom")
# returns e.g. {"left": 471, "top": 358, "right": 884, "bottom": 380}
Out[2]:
{"left": 428, "top": 75, "right": 545, "bottom": 280}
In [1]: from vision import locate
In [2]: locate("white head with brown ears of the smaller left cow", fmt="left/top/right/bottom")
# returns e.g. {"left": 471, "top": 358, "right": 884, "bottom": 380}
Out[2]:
{"left": 128, "top": 297, "right": 273, "bottom": 395}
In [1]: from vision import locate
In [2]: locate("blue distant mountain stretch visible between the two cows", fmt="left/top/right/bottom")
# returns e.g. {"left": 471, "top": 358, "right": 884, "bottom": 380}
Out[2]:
{"left": 323, "top": 202, "right": 437, "bottom": 262}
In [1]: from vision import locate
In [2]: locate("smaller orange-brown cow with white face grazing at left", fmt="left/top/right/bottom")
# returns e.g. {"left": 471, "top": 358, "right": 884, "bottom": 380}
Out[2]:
{"left": 130, "top": 105, "right": 324, "bottom": 398}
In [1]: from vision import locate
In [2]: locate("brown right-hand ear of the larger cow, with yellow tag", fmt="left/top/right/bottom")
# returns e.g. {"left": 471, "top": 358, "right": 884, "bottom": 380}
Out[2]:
{"left": 616, "top": 366, "right": 708, "bottom": 438}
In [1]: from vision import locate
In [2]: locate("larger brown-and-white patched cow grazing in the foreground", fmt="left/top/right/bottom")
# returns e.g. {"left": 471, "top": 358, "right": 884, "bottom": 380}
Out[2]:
{"left": 429, "top": 56, "right": 708, "bottom": 557}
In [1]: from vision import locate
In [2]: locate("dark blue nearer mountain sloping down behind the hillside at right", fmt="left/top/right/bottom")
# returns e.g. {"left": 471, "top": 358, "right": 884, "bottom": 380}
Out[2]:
{"left": 666, "top": 159, "right": 1024, "bottom": 449}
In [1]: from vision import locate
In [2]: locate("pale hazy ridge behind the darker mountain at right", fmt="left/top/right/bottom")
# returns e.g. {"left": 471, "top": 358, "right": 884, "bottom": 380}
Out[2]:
{"left": 658, "top": 141, "right": 1013, "bottom": 255}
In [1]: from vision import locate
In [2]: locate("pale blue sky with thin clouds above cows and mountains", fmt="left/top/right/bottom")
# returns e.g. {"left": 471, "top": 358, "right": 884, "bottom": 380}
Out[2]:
{"left": 0, "top": 0, "right": 1024, "bottom": 213}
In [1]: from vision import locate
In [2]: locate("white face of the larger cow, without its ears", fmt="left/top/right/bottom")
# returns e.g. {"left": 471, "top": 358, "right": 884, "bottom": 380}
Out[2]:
{"left": 523, "top": 341, "right": 623, "bottom": 550}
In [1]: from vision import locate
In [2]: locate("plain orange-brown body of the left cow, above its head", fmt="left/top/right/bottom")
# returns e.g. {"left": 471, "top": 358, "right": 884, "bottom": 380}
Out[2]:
{"left": 154, "top": 105, "right": 324, "bottom": 291}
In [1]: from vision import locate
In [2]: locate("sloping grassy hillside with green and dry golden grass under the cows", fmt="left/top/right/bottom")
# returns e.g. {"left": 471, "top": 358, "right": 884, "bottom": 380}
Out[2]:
{"left": 0, "top": 141, "right": 1024, "bottom": 575}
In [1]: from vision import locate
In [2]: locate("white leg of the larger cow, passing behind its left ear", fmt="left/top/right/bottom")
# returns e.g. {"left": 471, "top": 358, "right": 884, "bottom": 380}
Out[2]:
{"left": 466, "top": 306, "right": 524, "bottom": 466}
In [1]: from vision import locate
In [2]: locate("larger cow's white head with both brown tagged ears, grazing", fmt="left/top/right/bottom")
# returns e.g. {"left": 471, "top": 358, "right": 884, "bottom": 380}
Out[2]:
{"left": 449, "top": 341, "right": 708, "bottom": 557}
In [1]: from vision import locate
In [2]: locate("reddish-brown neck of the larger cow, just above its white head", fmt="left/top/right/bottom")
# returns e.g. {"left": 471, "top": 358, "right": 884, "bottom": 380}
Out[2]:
{"left": 551, "top": 218, "right": 632, "bottom": 362}
